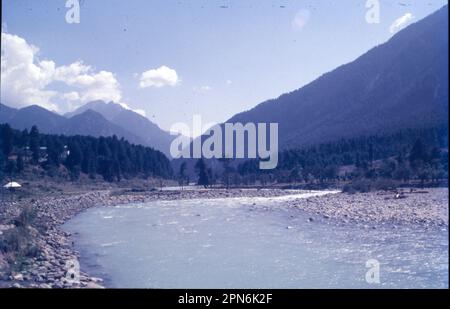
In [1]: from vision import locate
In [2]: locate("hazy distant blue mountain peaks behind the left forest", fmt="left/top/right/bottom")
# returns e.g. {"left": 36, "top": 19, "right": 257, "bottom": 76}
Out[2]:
{"left": 0, "top": 101, "right": 174, "bottom": 156}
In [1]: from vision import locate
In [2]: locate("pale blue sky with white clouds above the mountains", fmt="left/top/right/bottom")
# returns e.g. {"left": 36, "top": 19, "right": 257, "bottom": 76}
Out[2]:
{"left": 0, "top": 0, "right": 447, "bottom": 134}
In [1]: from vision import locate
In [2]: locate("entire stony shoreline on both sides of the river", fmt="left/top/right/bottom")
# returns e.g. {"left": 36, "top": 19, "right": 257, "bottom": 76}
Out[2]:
{"left": 0, "top": 188, "right": 448, "bottom": 288}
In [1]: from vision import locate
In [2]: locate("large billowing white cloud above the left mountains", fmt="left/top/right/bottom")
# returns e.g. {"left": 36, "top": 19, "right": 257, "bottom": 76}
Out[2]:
{"left": 0, "top": 32, "right": 122, "bottom": 112}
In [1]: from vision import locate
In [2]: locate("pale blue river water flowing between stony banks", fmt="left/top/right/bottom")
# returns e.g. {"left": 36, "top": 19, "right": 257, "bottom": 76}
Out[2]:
{"left": 64, "top": 192, "right": 448, "bottom": 288}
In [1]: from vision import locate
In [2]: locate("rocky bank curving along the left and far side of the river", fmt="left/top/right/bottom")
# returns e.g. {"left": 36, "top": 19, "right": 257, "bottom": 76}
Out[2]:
{"left": 0, "top": 189, "right": 302, "bottom": 288}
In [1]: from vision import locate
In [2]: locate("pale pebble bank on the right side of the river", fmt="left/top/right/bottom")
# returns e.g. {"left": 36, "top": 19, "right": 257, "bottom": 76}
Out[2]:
{"left": 289, "top": 188, "right": 449, "bottom": 228}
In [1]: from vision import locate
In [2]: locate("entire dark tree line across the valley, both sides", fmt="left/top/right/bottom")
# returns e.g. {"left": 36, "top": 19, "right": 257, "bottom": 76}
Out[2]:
{"left": 0, "top": 124, "right": 448, "bottom": 188}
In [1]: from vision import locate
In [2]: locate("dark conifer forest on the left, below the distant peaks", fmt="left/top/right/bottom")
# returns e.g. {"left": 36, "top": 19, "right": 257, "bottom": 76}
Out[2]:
{"left": 0, "top": 124, "right": 173, "bottom": 182}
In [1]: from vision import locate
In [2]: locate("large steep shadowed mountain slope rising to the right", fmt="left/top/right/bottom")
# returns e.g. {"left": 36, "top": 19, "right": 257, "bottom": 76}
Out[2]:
{"left": 227, "top": 6, "right": 448, "bottom": 148}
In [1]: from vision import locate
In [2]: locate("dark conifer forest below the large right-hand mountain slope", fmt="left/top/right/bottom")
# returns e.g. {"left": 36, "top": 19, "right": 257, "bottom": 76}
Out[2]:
{"left": 192, "top": 126, "right": 448, "bottom": 187}
